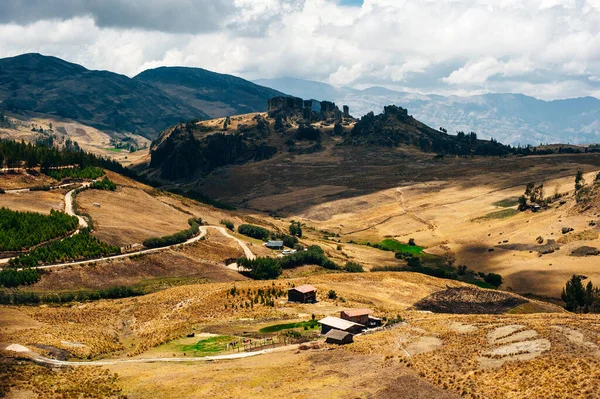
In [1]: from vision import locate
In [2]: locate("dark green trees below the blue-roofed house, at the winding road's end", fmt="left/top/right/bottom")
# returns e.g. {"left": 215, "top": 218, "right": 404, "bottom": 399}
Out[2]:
{"left": 238, "top": 245, "right": 342, "bottom": 280}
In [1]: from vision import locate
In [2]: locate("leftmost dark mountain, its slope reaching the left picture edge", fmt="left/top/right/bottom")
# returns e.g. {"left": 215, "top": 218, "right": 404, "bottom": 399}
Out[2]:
{"left": 0, "top": 54, "right": 207, "bottom": 137}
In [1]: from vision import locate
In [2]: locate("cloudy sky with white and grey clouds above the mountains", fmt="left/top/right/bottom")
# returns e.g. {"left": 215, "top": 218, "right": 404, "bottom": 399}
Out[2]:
{"left": 0, "top": 0, "right": 600, "bottom": 100}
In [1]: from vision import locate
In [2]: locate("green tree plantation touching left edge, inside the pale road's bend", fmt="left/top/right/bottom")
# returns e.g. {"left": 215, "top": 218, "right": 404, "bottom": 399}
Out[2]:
{"left": 0, "top": 208, "right": 79, "bottom": 251}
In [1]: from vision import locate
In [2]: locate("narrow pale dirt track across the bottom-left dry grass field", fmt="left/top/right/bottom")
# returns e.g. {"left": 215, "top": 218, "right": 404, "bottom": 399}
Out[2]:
{"left": 5, "top": 344, "right": 299, "bottom": 367}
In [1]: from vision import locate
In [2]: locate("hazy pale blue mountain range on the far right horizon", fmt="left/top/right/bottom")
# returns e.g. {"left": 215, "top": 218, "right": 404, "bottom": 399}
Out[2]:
{"left": 257, "top": 78, "right": 600, "bottom": 145}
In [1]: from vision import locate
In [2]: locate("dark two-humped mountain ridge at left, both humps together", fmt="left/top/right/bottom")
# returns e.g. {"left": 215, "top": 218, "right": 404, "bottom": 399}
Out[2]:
{"left": 0, "top": 54, "right": 281, "bottom": 138}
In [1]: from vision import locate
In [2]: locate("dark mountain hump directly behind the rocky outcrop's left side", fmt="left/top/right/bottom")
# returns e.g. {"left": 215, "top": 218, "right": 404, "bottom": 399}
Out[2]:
{"left": 133, "top": 67, "right": 283, "bottom": 118}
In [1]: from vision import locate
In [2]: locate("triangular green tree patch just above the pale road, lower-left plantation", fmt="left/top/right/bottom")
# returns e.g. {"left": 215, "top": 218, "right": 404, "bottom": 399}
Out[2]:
{"left": 9, "top": 229, "right": 121, "bottom": 267}
